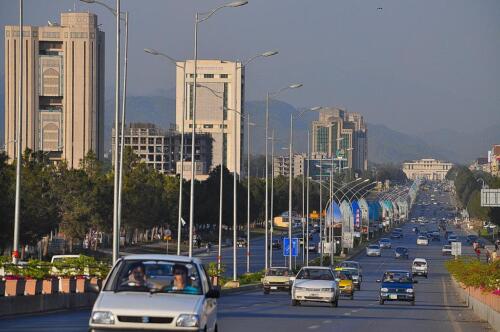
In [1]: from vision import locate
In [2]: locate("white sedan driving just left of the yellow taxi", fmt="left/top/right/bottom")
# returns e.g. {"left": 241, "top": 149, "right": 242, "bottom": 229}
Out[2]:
{"left": 292, "top": 266, "right": 340, "bottom": 307}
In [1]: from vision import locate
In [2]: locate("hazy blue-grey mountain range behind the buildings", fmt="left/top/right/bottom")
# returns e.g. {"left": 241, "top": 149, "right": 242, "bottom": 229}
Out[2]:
{"left": 0, "top": 90, "right": 500, "bottom": 163}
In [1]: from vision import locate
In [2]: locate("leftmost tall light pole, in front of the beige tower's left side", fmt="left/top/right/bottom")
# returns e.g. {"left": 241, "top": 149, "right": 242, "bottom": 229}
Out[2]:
{"left": 12, "top": 0, "right": 24, "bottom": 264}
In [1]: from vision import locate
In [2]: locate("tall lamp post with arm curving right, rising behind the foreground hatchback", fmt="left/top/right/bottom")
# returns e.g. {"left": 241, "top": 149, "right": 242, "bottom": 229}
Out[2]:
{"left": 189, "top": 0, "right": 248, "bottom": 257}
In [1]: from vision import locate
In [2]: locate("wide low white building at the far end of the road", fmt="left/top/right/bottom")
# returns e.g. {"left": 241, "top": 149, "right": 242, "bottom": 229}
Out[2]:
{"left": 403, "top": 159, "right": 453, "bottom": 181}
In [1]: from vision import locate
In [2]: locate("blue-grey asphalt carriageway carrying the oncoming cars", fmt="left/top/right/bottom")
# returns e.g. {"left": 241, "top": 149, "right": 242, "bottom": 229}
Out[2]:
{"left": 0, "top": 183, "right": 490, "bottom": 332}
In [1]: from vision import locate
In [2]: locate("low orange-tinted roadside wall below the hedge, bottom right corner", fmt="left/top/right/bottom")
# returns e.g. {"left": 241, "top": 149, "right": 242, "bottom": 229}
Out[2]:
{"left": 452, "top": 278, "right": 500, "bottom": 332}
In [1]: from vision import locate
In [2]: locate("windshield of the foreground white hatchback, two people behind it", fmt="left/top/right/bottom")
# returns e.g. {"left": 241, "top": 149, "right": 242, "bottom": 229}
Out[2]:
{"left": 104, "top": 260, "right": 203, "bottom": 295}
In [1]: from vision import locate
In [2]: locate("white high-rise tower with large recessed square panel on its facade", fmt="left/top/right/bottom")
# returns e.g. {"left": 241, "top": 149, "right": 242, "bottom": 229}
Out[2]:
{"left": 176, "top": 60, "right": 245, "bottom": 173}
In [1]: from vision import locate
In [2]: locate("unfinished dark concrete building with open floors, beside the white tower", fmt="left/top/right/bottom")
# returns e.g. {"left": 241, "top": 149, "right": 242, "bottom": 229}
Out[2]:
{"left": 112, "top": 123, "right": 212, "bottom": 180}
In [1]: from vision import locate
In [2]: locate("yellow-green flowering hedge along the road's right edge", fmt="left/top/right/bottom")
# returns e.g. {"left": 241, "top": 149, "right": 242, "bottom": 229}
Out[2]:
{"left": 445, "top": 257, "right": 500, "bottom": 293}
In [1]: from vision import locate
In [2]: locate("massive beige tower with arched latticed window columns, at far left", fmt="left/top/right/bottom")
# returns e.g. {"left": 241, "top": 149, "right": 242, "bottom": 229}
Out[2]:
{"left": 4, "top": 12, "right": 104, "bottom": 167}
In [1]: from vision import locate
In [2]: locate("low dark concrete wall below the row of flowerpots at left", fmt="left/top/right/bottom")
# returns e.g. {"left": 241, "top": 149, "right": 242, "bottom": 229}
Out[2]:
{"left": 0, "top": 293, "right": 97, "bottom": 317}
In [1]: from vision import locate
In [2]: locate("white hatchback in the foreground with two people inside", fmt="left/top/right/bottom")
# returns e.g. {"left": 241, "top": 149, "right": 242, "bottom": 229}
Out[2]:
{"left": 89, "top": 255, "right": 220, "bottom": 331}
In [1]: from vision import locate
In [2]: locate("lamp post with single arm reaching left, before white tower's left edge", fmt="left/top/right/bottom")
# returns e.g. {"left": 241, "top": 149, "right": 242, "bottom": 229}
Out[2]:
{"left": 144, "top": 48, "right": 187, "bottom": 256}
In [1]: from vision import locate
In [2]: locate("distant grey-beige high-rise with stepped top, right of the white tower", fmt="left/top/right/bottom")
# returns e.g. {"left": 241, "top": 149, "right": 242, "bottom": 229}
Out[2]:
{"left": 312, "top": 108, "right": 368, "bottom": 172}
